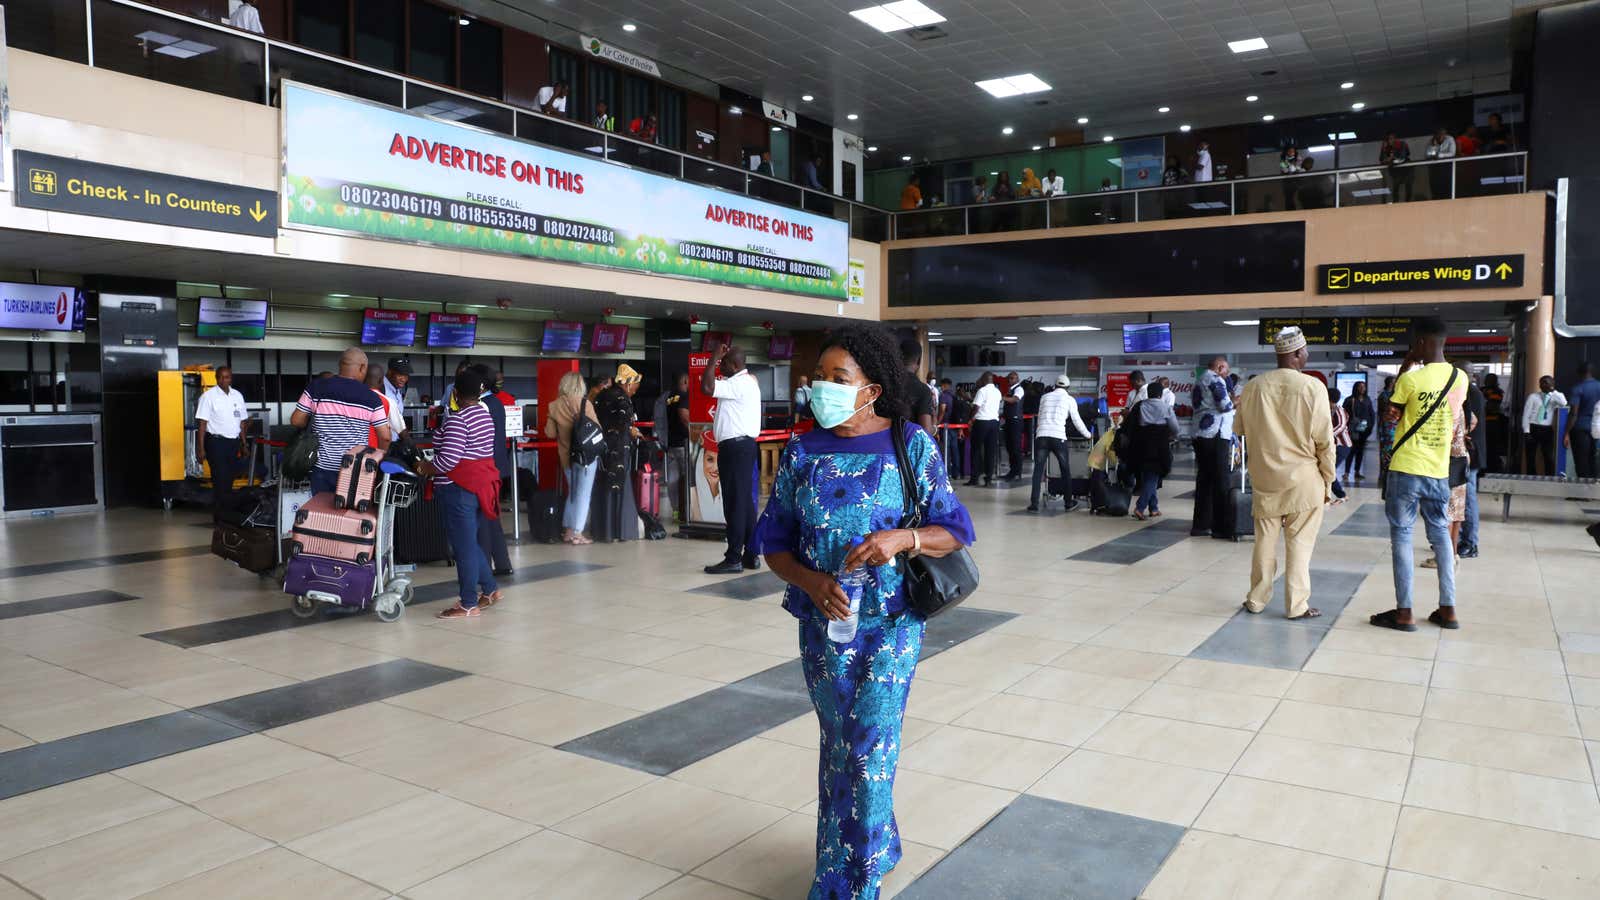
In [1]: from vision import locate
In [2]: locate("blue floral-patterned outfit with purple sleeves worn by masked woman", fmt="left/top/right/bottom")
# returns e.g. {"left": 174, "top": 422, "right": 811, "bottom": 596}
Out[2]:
{"left": 755, "top": 424, "right": 974, "bottom": 900}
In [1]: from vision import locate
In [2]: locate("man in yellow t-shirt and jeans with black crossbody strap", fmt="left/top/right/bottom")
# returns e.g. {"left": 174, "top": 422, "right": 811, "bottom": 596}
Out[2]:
{"left": 1371, "top": 317, "right": 1467, "bottom": 631}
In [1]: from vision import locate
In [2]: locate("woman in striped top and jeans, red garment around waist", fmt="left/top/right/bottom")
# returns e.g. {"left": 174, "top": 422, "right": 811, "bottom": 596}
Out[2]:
{"left": 418, "top": 368, "right": 501, "bottom": 618}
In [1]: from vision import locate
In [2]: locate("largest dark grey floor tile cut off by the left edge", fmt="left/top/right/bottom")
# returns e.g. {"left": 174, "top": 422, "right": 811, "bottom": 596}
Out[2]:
{"left": 0, "top": 709, "right": 246, "bottom": 799}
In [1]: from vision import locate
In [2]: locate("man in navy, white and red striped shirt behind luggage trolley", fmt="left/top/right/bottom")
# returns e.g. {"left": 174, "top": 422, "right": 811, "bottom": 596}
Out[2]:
{"left": 290, "top": 348, "right": 390, "bottom": 493}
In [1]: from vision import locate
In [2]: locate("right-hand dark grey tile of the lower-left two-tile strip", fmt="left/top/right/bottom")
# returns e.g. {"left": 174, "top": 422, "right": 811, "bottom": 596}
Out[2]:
{"left": 192, "top": 660, "right": 467, "bottom": 732}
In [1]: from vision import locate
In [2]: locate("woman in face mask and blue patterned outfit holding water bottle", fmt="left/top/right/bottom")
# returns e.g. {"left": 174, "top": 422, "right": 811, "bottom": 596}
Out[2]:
{"left": 755, "top": 325, "right": 973, "bottom": 900}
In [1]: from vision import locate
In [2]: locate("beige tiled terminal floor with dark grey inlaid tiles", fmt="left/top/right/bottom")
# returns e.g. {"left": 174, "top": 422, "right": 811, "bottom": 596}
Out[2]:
{"left": 0, "top": 480, "right": 1600, "bottom": 900}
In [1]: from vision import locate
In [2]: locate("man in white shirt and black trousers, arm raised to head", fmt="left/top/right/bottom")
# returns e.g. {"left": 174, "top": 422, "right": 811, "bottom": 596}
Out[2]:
{"left": 701, "top": 344, "right": 762, "bottom": 575}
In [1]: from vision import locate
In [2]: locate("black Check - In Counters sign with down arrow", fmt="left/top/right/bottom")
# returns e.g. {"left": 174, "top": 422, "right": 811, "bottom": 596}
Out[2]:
{"left": 16, "top": 151, "right": 278, "bottom": 237}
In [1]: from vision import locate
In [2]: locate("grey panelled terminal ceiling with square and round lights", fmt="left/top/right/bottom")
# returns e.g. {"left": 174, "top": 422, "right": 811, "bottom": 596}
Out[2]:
{"left": 480, "top": 0, "right": 1547, "bottom": 162}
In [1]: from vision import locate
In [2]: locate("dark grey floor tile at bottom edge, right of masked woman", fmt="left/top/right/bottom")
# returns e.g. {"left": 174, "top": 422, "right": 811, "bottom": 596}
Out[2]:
{"left": 899, "top": 794, "right": 1184, "bottom": 900}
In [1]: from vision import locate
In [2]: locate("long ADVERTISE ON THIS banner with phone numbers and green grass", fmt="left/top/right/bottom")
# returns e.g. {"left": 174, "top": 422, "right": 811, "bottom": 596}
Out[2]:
{"left": 280, "top": 83, "right": 850, "bottom": 299}
